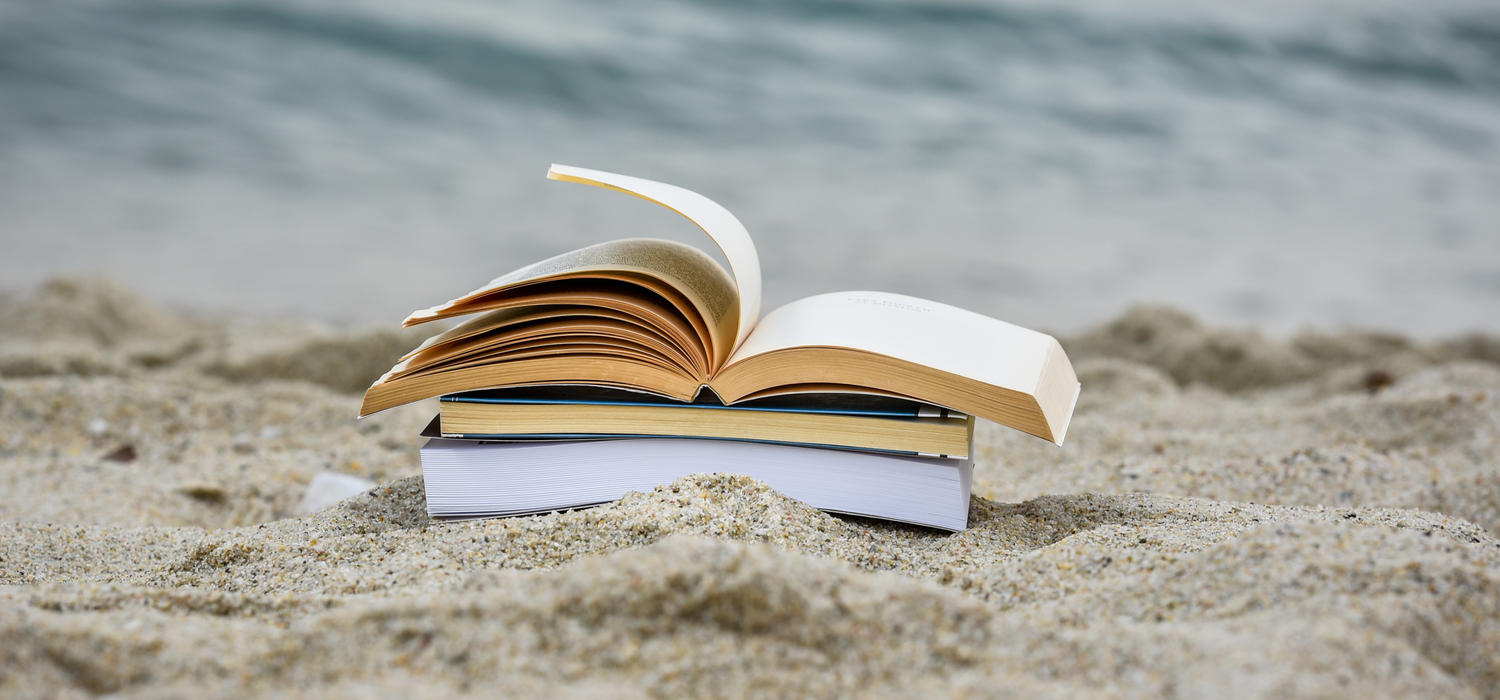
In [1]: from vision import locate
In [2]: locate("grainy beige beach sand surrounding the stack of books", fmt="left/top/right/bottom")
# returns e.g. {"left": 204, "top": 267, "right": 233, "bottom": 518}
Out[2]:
{"left": 0, "top": 280, "right": 1500, "bottom": 697}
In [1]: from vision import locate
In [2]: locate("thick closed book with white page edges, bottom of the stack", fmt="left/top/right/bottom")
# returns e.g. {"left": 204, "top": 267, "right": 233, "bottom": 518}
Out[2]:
{"left": 422, "top": 438, "right": 974, "bottom": 531}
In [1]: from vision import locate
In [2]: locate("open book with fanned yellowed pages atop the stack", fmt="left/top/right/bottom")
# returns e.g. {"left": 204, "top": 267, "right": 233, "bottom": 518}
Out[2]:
{"left": 360, "top": 165, "right": 1079, "bottom": 444}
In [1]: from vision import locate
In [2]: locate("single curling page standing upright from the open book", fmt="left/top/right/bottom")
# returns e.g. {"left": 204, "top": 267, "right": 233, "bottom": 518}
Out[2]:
{"left": 548, "top": 163, "right": 761, "bottom": 345}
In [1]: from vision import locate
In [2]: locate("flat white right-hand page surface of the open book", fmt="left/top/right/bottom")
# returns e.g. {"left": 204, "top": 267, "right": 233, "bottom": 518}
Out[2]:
{"left": 729, "top": 292, "right": 1056, "bottom": 394}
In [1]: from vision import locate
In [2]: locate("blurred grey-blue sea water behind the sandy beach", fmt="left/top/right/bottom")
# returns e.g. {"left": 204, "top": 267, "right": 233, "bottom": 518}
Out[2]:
{"left": 0, "top": 0, "right": 1500, "bottom": 334}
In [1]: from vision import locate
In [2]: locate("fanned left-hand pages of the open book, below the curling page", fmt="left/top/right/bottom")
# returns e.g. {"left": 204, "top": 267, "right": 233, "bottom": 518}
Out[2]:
{"left": 360, "top": 238, "right": 737, "bottom": 415}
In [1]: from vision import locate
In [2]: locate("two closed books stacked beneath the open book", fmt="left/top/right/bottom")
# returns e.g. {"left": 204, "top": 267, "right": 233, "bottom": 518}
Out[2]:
{"left": 422, "top": 387, "right": 974, "bottom": 529}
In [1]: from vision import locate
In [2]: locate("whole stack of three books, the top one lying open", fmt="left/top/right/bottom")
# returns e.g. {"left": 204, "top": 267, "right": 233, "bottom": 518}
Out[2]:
{"left": 360, "top": 165, "right": 1079, "bottom": 531}
